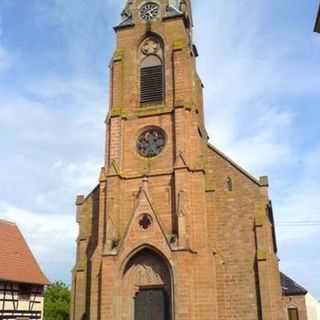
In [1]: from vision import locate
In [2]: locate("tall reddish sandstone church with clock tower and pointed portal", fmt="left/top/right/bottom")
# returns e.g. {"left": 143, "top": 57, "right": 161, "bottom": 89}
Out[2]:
{"left": 71, "top": 0, "right": 287, "bottom": 320}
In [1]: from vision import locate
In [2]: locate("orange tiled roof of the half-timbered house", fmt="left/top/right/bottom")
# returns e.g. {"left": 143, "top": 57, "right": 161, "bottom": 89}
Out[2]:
{"left": 0, "top": 220, "right": 49, "bottom": 285}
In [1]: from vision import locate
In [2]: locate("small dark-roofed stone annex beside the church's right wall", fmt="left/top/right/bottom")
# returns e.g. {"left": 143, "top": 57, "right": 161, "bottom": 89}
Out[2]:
{"left": 281, "top": 273, "right": 309, "bottom": 320}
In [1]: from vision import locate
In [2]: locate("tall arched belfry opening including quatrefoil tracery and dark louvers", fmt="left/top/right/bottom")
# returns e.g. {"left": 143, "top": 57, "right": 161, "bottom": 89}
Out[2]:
{"left": 140, "top": 37, "right": 164, "bottom": 104}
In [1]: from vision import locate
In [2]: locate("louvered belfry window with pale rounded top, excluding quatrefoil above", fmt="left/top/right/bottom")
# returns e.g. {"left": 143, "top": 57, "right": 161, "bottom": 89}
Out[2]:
{"left": 140, "top": 55, "right": 164, "bottom": 103}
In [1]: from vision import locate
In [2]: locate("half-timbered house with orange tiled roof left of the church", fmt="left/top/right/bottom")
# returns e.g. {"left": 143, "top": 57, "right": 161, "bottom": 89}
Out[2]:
{"left": 0, "top": 220, "right": 48, "bottom": 320}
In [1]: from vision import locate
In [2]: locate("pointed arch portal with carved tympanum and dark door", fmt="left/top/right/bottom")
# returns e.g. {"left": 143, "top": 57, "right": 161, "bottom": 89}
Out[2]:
{"left": 122, "top": 248, "right": 172, "bottom": 320}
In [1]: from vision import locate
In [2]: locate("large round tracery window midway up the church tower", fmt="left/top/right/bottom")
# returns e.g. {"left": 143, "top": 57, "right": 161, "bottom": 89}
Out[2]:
{"left": 137, "top": 128, "right": 166, "bottom": 158}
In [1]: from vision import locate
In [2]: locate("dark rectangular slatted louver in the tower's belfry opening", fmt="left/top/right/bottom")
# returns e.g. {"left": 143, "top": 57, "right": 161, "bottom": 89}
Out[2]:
{"left": 140, "top": 65, "right": 164, "bottom": 103}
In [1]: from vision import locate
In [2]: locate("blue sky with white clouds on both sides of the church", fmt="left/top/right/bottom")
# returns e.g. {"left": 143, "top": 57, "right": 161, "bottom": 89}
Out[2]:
{"left": 0, "top": 0, "right": 320, "bottom": 299}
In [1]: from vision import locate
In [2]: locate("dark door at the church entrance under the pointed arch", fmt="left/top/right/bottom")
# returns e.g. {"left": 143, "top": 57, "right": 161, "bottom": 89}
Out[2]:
{"left": 134, "top": 289, "right": 170, "bottom": 320}
